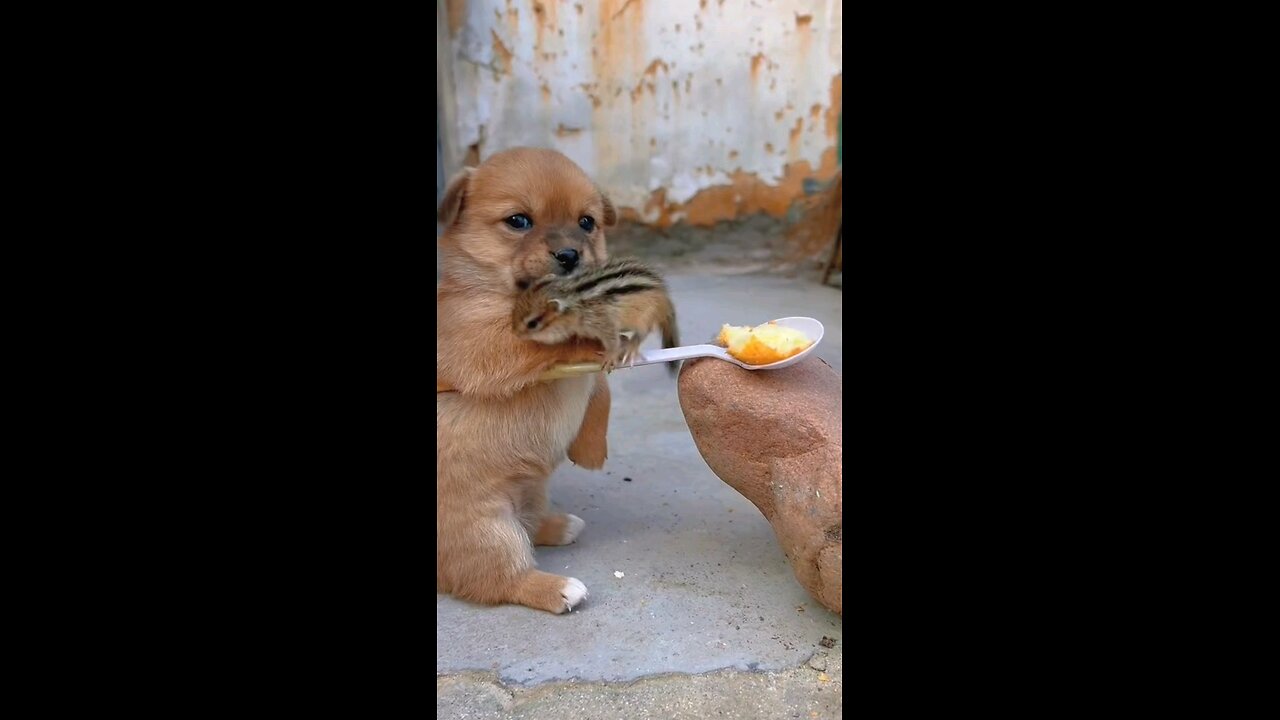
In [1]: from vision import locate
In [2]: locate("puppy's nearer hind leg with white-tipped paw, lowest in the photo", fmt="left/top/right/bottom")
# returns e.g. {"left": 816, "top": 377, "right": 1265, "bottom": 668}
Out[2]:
{"left": 435, "top": 504, "right": 586, "bottom": 614}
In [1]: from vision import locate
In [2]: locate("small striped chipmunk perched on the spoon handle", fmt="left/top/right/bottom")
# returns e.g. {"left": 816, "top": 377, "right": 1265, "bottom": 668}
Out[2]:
{"left": 511, "top": 254, "right": 680, "bottom": 374}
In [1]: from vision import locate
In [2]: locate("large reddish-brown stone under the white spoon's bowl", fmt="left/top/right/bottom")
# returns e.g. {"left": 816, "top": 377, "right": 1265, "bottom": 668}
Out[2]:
{"left": 680, "top": 357, "right": 844, "bottom": 615}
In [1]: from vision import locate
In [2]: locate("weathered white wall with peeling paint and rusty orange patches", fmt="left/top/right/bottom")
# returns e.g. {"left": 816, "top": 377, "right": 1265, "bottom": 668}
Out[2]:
{"left": 438, "top": 0, "right": 842, "bottom": 225}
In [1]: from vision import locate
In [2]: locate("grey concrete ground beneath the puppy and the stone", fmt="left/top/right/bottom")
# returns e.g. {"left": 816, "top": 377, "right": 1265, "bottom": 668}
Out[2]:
{"left": 435, "top": 228, "right": 844, "bottom": 719}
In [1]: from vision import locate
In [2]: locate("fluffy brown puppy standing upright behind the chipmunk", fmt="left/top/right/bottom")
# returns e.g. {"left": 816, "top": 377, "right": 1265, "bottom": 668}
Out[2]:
{"left": 435, "top": 147, "right": 617, "bottom": 612}
